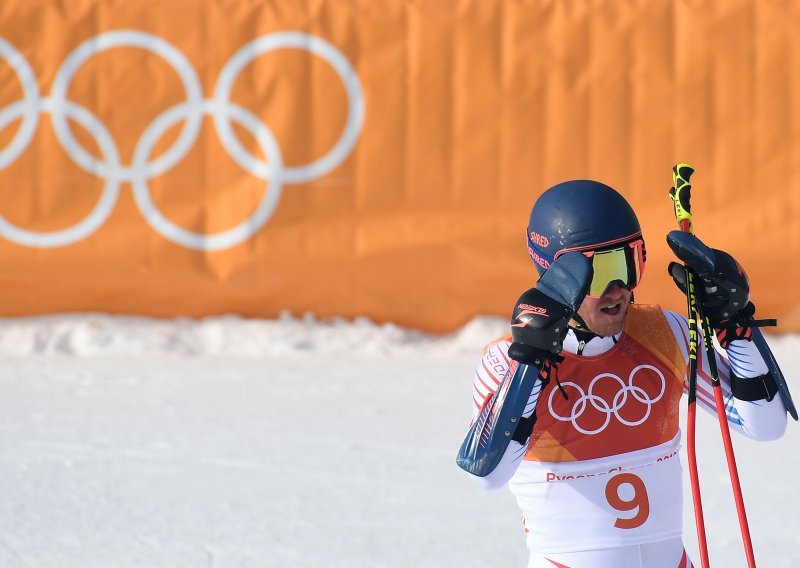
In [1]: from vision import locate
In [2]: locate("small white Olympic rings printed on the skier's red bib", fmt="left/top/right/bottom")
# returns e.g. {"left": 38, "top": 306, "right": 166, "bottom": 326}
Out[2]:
{"left": 547, "top": 365, "right": 667, "bottom": 436}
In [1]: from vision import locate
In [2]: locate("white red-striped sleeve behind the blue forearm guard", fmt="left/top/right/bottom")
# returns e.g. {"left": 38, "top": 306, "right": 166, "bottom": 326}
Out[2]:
{"left": 469, "top": 340, "right": 542, "bottom": 490}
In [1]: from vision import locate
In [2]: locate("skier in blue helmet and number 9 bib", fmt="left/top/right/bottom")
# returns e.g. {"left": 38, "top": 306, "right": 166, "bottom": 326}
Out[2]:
{"left": 465, "top": 180, "right": 786, "bottom": 568}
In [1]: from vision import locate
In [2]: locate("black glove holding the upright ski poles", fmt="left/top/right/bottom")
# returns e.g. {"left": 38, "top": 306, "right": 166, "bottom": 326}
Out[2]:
{"left": 667, "top": 231, "right": 755, "bottom": 328}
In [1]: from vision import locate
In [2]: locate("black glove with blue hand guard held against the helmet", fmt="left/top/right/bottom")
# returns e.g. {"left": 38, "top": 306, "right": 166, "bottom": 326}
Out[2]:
{"left": 508, "top": 252, "right": 592, "bottom": 365}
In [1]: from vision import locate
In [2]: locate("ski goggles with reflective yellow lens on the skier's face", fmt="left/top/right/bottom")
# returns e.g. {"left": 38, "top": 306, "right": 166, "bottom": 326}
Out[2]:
{"left": 560, "top": 239, "right": 645, "bottom": 298}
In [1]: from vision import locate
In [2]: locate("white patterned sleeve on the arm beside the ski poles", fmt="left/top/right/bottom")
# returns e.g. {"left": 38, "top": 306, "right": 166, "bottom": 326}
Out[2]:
{"left": 664, "top": 310, "right": 786, "bottom": 441}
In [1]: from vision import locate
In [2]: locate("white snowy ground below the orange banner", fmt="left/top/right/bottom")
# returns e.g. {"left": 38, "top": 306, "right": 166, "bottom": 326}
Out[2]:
{"left": 0, "top": 315, "right": 800, "bottom": 568}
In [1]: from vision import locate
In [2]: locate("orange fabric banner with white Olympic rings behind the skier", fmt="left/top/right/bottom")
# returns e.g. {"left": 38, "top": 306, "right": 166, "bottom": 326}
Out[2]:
{"left": 0, "top": 0, "right": 800, "bottom": 331}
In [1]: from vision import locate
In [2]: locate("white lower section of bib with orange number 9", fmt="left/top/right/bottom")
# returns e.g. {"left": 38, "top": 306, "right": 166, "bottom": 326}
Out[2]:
{"left": 509, "top": 434, "right": 682, "bottom": 553}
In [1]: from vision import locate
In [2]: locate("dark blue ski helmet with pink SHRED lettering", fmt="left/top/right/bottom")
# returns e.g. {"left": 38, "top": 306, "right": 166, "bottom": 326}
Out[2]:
{"left": 528, "top": 180, "right": 644, "bottom": 275}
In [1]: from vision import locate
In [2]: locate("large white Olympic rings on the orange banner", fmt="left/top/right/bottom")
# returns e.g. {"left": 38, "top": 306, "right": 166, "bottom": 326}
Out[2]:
{"left": 0, "top": 30, "right": 365, "bottom": 251}
